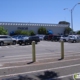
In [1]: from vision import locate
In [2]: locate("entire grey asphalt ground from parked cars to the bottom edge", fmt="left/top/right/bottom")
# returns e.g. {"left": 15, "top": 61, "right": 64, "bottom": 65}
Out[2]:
{"left": 0, "top": 41, "right": 80, "bottom": 80}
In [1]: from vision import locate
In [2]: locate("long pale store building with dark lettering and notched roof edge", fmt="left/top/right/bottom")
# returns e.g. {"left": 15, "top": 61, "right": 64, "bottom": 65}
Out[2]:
{"left": 0, "top": 22, "right": 69, "bottom": 34}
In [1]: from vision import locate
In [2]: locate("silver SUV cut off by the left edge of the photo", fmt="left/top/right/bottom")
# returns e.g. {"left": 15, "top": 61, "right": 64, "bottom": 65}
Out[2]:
{"left": 0, "top": 35, "right": 16, "bottom": 46}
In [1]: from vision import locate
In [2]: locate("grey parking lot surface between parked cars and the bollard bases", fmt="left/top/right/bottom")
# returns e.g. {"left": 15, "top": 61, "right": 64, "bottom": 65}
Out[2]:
{"left": 0, "top": 41, "right": 80, "bottom": 62}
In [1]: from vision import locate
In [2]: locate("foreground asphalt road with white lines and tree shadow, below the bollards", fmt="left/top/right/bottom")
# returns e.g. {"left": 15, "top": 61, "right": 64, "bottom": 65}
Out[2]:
{"left": 0, "top": 59, "right": 80, "bottom": 80}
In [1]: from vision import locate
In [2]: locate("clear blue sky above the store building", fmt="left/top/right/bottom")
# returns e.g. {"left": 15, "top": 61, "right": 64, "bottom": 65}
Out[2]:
{"left": 0, "top": 0, "right": 80, "bottom": 31}
